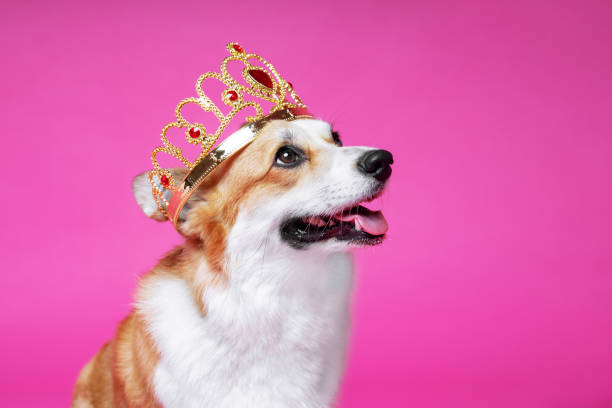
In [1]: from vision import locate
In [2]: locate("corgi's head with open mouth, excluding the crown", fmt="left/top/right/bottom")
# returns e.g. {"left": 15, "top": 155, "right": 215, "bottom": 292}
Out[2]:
{"left": 133, "top": 119, "right": 393, "bottom": 258}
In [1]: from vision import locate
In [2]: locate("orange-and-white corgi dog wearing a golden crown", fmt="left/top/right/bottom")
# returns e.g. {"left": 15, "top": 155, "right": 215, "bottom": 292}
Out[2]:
{"left": 72, "top": 118, "right": 393, "bottom": 408}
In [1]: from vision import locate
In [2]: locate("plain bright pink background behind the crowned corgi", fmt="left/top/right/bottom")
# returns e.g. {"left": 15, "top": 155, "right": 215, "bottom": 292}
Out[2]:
{"left": 0, "top": 0, "right": 612, "bottom": 408}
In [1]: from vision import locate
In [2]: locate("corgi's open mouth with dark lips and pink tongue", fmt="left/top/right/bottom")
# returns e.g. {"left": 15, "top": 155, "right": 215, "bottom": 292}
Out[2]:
{"left": 280, "top": 200, "right": 388, "bottom": 248}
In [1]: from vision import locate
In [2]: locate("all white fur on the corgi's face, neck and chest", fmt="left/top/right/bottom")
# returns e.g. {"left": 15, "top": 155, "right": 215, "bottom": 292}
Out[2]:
{"left": 138, "top": 120, "right": 382, "bottom": 408}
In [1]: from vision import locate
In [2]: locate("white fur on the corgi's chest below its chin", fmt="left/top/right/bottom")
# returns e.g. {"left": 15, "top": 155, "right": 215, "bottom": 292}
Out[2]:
{"left": 140, "top": 248, "right": 352, "bottom": 408}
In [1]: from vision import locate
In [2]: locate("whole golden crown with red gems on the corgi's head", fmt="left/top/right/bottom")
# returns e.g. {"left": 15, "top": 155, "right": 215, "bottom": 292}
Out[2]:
{"left": 149, "top": 43, "right": 312, "bottom": 225}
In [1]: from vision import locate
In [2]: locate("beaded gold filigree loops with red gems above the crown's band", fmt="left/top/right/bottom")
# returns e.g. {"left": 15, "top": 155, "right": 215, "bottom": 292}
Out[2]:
{"left": 149, "top": 43, "right": 306, "bottom": 216}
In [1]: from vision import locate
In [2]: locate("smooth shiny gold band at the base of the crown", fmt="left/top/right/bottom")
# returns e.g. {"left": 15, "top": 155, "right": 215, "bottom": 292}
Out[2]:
{"left": 167, "top": 108, "right": 313, "bottom": 226}
